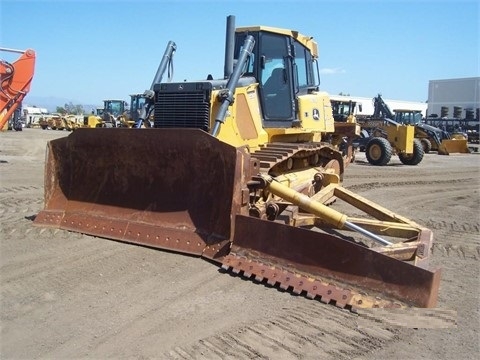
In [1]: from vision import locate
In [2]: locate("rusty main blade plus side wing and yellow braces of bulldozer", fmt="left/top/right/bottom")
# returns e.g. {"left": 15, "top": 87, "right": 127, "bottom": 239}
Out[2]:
{"left": 34, "top": 128, "right": 440, "bottom": 309}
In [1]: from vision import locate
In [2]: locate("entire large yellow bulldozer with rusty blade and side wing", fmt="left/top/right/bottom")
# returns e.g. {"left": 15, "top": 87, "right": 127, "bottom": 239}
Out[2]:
{"left": 34, "top": 16, "right": 441, "bottom": 311}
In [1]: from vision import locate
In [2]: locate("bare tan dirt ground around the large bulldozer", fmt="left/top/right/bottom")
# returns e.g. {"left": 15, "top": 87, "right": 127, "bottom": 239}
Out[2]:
{"left": 0, "top": 129, "right": 480, "bottom": 359}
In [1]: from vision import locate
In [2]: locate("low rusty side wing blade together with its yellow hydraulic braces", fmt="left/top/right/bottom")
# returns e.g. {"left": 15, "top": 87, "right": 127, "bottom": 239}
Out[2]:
{"left": 223, "top": 175, "right": 440, "bottom": 309}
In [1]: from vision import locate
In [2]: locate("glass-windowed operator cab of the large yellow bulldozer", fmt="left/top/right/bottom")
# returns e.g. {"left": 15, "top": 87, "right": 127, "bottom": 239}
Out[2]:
{"left": 235, "top": 27, "right": 319, "bottom": 127}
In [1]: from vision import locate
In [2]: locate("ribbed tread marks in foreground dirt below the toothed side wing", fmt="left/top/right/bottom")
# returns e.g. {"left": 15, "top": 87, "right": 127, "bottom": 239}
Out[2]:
{"left": 162, "top": 299, "right": 396, "bottom": 360}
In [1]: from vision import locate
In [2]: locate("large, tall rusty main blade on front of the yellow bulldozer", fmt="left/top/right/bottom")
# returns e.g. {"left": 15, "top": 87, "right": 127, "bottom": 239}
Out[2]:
{"left": 35, "top": 128, "right": 248, "bottom": 257}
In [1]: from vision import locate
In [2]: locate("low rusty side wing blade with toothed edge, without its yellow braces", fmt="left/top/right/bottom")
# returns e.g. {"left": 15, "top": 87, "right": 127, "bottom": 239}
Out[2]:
{"left": 223, "top": 216, "right": 440, "bottom": 307}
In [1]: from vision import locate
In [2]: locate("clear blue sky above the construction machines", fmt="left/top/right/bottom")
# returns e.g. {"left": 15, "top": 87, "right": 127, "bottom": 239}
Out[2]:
{"left": 0, "top": 0, "right": 480, "bottom": 105}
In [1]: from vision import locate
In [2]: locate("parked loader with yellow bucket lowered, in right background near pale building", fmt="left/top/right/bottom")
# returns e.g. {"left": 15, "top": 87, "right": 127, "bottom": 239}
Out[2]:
{"left": 395, "top": 109, "right": 470, "bottom": 155}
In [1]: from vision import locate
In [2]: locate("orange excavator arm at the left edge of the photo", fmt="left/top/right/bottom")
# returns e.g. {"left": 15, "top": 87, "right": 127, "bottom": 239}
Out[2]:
{"left": 0, "top": 48, "right": 36, "bottom": 129}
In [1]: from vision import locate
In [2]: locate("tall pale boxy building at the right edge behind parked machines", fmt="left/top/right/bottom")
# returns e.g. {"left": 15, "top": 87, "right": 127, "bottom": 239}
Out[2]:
{"left": 427, "top": 77, "right": 480, "bottom": 119}
